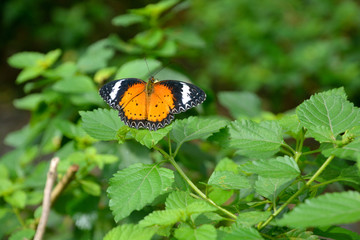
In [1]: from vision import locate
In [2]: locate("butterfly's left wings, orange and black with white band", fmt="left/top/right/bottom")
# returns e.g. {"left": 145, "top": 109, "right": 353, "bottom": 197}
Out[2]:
{"left": 99, "top": 78, "right": 147, "bottom": 128}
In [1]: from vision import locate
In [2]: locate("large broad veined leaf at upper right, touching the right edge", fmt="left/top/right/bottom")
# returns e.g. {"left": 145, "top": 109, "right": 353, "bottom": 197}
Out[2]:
{"left": 296, "top": 92, "right": 360, "bottom": 142}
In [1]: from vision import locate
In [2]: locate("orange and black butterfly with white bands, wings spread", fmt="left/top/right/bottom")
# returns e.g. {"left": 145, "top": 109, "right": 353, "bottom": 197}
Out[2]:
{"left": 99, "top": 76, "right": 206, "bottom": 131}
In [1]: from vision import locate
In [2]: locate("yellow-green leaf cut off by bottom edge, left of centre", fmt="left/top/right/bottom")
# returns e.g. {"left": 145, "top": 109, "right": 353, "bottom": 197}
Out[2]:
{"left": 104, "top": 224, "right": 156, "bottom": 240}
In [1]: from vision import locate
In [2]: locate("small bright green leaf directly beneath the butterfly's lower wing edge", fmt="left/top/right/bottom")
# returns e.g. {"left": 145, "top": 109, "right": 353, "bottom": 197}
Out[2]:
{"left": 130, "top": 125, "right": 171, "bottom": 148}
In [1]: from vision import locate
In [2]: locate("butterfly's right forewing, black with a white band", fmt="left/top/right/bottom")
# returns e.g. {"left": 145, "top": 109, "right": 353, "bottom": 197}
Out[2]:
{"left": 156, "top": 80, "right": 206, "bottom": 114}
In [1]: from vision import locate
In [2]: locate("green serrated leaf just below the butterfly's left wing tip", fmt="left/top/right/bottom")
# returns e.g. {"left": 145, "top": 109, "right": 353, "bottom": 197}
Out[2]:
{"left": 79, "top": 109, "right": 124, "bottom": 140}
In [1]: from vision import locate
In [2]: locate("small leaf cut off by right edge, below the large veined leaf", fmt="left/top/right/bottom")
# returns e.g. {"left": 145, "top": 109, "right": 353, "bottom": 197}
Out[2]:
{"left": 322, "top": 139, "right": 360, "bottom": 161}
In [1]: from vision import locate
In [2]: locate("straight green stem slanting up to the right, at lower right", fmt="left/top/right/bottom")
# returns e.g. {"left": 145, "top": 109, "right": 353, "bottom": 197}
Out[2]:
{"left": 258, "top": 155, "right": 335, "bottom": 230}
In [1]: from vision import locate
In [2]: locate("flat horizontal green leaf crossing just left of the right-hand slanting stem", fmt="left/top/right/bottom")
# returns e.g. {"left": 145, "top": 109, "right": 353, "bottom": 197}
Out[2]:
{"left": 240, "top": 156, "right": 300, "bottom": 179}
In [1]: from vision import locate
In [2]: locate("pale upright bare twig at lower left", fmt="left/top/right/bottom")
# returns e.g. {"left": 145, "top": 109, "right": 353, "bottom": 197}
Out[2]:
{"left": 34, "top": 157, "right": 60, "bottom": 240}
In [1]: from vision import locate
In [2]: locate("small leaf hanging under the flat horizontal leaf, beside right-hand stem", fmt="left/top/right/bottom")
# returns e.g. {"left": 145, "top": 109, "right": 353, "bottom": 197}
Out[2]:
{"left": 255, "top": 176, "right": 294, "bottom": 201}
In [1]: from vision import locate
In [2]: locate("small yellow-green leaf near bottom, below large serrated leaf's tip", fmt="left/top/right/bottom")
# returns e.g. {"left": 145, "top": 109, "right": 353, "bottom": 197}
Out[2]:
{"left": 139, "top": 209, "right": 185, "bottom": 227}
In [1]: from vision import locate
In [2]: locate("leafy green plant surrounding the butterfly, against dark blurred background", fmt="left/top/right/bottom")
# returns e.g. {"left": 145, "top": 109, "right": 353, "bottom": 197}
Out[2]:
{"left": 0, "top": 0, "right": 360, "bottom": 240}
